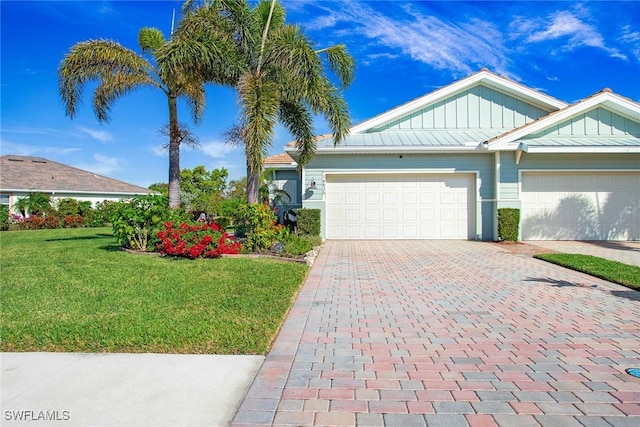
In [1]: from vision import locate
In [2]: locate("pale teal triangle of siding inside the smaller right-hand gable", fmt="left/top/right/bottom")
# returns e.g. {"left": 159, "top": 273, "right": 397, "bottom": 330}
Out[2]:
{"left": 524, "top": 108, "right": 640, "bottom": 139}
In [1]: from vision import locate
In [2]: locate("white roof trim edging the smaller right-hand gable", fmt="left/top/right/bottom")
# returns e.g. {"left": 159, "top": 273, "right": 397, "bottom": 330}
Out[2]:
{"left": 489, "top": 91, "right": 640, "bottom": 150}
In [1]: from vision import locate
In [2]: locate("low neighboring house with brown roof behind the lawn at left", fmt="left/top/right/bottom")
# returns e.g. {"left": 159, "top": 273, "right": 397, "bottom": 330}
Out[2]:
{"left": 0, "top": 155, "right": 153, "bottom": 214}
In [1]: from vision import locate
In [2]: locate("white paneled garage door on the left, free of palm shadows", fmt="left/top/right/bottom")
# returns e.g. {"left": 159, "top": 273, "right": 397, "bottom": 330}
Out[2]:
{"left": 326, "top": 174, "right": 475, "bottom": 239}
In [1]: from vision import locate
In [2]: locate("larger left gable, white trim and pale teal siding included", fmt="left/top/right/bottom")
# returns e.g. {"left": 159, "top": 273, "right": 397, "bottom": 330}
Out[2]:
{"left": 351, "top": 70, "right": 567, "bottom": 134}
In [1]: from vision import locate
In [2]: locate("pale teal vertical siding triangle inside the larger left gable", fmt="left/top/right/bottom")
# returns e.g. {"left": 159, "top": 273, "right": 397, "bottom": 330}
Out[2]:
{"left": 369, "top": 85, "right": 549, "bottom": 132}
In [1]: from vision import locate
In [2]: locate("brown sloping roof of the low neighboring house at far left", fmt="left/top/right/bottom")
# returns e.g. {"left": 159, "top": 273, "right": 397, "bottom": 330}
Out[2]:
{"left": 0, "top": 155, "right": 153, "bottom": 195}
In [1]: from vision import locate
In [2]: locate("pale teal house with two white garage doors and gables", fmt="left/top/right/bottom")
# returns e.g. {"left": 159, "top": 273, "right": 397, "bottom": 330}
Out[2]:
{"left": 272, "top": 69, "right": 640, "bottom": 240}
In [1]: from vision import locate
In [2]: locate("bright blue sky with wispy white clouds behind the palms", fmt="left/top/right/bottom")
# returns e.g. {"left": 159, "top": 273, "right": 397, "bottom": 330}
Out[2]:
{"left": 0, "top": 0, "right": 640, "bottom": 187}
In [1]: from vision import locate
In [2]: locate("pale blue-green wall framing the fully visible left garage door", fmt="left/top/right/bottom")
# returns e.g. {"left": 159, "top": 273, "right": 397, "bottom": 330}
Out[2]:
{"left": 302, "top": 153, "right": 495, "bottom": 240}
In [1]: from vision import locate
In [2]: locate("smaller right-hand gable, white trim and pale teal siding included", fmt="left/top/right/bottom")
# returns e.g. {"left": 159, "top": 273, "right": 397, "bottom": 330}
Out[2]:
{"left": 488, "top": 89, "right": 640, "bottom": 150}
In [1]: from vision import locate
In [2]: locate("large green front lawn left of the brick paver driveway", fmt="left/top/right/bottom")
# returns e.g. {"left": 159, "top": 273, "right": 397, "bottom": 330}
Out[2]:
{"left": 0, "top": 228, "right": 307, "bottom": 354}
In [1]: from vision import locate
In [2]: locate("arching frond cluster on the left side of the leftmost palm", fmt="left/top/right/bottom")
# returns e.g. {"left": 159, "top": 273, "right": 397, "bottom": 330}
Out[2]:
{"left": 58, "top": 40, "right": 161, "bottom": 122}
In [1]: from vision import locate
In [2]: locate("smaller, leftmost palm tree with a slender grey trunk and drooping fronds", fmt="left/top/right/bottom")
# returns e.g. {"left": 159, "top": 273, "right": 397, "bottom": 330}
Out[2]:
{"left": 58, "top": 28, "right": 232, "bottom": 208}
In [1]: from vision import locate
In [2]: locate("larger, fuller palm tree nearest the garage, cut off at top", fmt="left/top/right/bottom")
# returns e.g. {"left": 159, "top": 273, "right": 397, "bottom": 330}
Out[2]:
{"left": 168, "top": 0, "right": 354, "bottom": 203}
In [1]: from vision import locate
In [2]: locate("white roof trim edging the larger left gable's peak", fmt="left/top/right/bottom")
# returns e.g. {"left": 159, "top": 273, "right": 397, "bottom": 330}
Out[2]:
{"left": 351, "top": 70, "right": 568, "bottom": 133}
